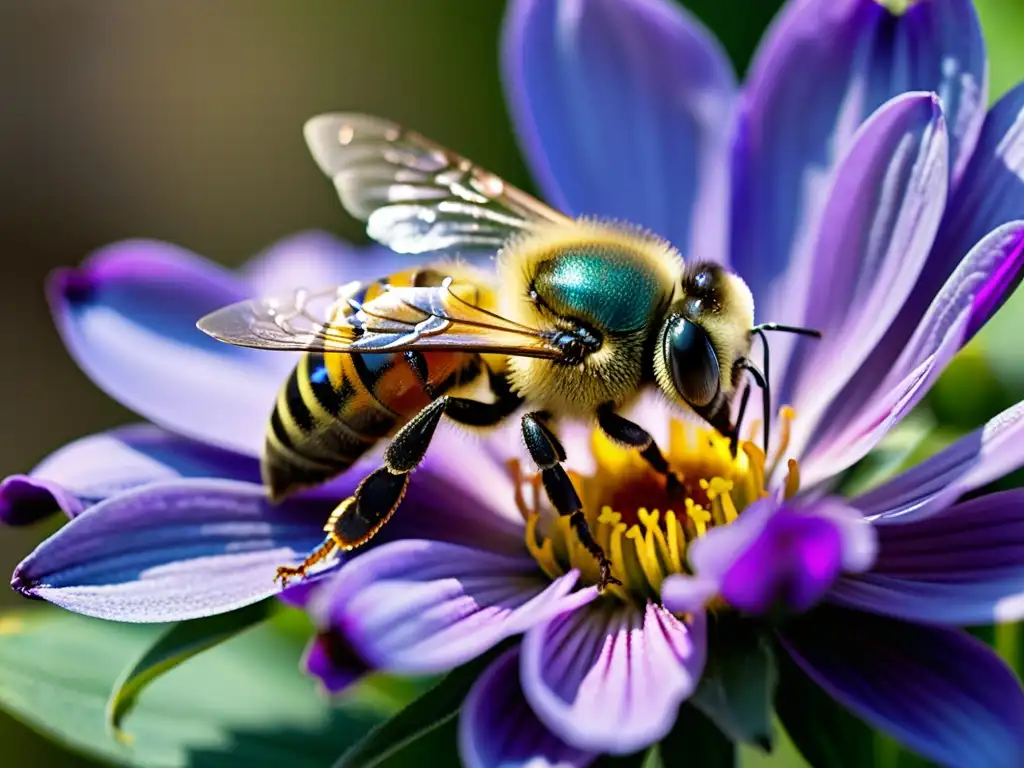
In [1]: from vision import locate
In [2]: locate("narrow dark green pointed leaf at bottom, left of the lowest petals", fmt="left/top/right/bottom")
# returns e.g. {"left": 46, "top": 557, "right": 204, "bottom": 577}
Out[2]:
{"left": 334, "top": 645, "right": 505, "bottom": 768}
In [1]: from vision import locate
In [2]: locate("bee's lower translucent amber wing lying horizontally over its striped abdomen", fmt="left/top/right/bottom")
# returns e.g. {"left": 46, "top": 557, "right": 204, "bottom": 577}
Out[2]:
{"left": 198, "top": 278, "right": 562, "bottom": 357}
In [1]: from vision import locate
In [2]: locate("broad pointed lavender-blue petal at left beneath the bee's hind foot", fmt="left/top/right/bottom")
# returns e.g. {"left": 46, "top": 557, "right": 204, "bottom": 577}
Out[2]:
{"left": 11, "top": 479, "right": 333, "bottom": 622}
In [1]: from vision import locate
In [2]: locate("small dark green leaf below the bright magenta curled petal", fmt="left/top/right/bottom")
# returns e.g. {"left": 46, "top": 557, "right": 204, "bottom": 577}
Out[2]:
{"left": 690, "top": 621, "right": 778, "bottom": 752}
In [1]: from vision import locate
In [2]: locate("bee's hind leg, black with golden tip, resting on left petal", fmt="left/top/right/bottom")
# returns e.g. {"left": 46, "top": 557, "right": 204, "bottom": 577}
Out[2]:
{"left": 275, "top": 369, "right": 521, "bottom": 583}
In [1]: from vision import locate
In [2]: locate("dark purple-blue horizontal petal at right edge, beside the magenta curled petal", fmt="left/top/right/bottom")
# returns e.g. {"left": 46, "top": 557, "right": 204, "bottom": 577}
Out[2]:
{"left": 829, "top": 489, "right": 1024, "bottom": 626}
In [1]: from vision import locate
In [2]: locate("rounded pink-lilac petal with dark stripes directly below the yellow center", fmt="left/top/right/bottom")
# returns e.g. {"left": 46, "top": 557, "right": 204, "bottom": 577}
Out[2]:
{"left": 522, "top": 601, "right": 707, "bottom": 754}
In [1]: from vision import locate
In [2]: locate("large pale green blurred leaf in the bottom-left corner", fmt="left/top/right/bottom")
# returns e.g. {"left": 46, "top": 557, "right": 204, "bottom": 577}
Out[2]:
{"left": 0, "top": 610, "right": 382, "bottom": 768}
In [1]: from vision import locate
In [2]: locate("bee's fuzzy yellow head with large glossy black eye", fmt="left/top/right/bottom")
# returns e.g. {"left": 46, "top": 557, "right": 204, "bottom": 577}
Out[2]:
{"left": 654, "top": 263, "right": 754, "bottom": 412}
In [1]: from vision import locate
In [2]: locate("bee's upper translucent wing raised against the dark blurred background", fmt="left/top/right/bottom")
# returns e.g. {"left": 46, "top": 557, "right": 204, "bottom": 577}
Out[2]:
{"left": 305, "top": 113, "right": 567, "bottom": 259}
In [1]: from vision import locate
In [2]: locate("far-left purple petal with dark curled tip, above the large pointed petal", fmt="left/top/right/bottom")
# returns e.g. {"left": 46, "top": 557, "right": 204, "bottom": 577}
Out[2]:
{"left": 0, "top": 424, "right": 259, "bottom": 525}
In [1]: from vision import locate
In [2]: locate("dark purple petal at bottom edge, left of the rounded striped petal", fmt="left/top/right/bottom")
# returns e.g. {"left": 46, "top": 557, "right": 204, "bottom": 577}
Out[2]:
{"left": 459, "top": 648, "right": 597, "bottom": 768}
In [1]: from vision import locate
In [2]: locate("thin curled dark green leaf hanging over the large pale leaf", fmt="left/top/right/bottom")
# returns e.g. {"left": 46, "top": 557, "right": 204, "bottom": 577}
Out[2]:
{"left": 106, "top": 600, "right": 275, "bottom": 740}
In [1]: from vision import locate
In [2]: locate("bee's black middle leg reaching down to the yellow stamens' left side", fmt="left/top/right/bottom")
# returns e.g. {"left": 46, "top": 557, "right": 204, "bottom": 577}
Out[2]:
{"left": 522, "top": 411, "right": 622, "bottom": 590}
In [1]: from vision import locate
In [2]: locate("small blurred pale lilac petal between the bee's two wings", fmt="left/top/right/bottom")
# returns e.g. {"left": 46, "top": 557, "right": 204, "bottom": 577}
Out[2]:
{"left": 241, "top": 231, "right": 403, "bottom": 297}
